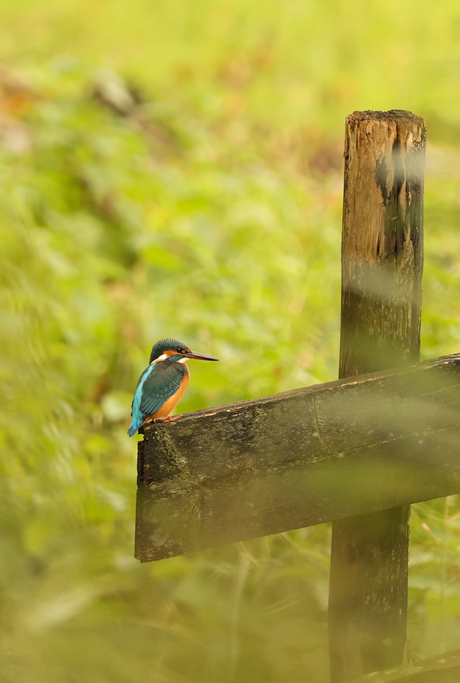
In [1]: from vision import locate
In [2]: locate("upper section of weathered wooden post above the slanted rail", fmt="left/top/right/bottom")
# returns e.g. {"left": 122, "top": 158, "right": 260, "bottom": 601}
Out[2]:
{"left": 339, "top": 111, "right": 426, "bottom": 377}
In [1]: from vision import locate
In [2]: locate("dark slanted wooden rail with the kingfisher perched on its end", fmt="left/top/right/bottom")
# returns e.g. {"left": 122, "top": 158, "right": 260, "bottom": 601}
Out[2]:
{"left": 136, "top": 354, "right": 460, "bottom": 562}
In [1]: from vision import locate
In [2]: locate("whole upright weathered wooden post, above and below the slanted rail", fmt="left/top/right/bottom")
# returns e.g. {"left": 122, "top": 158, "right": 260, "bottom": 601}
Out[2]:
{"left": 329, "top": 111, "right": 425, "bottom": 683}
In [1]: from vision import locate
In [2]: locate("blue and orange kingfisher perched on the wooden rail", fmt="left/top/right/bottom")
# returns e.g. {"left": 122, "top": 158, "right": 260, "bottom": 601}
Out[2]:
{"left": 128, "top": 339, "right": 219, "bottom": 437}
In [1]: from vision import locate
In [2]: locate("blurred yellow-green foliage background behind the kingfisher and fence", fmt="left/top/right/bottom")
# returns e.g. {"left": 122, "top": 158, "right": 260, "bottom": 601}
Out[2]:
{"left": 0, "top": 0, "right": 460, "bottom": 683}
